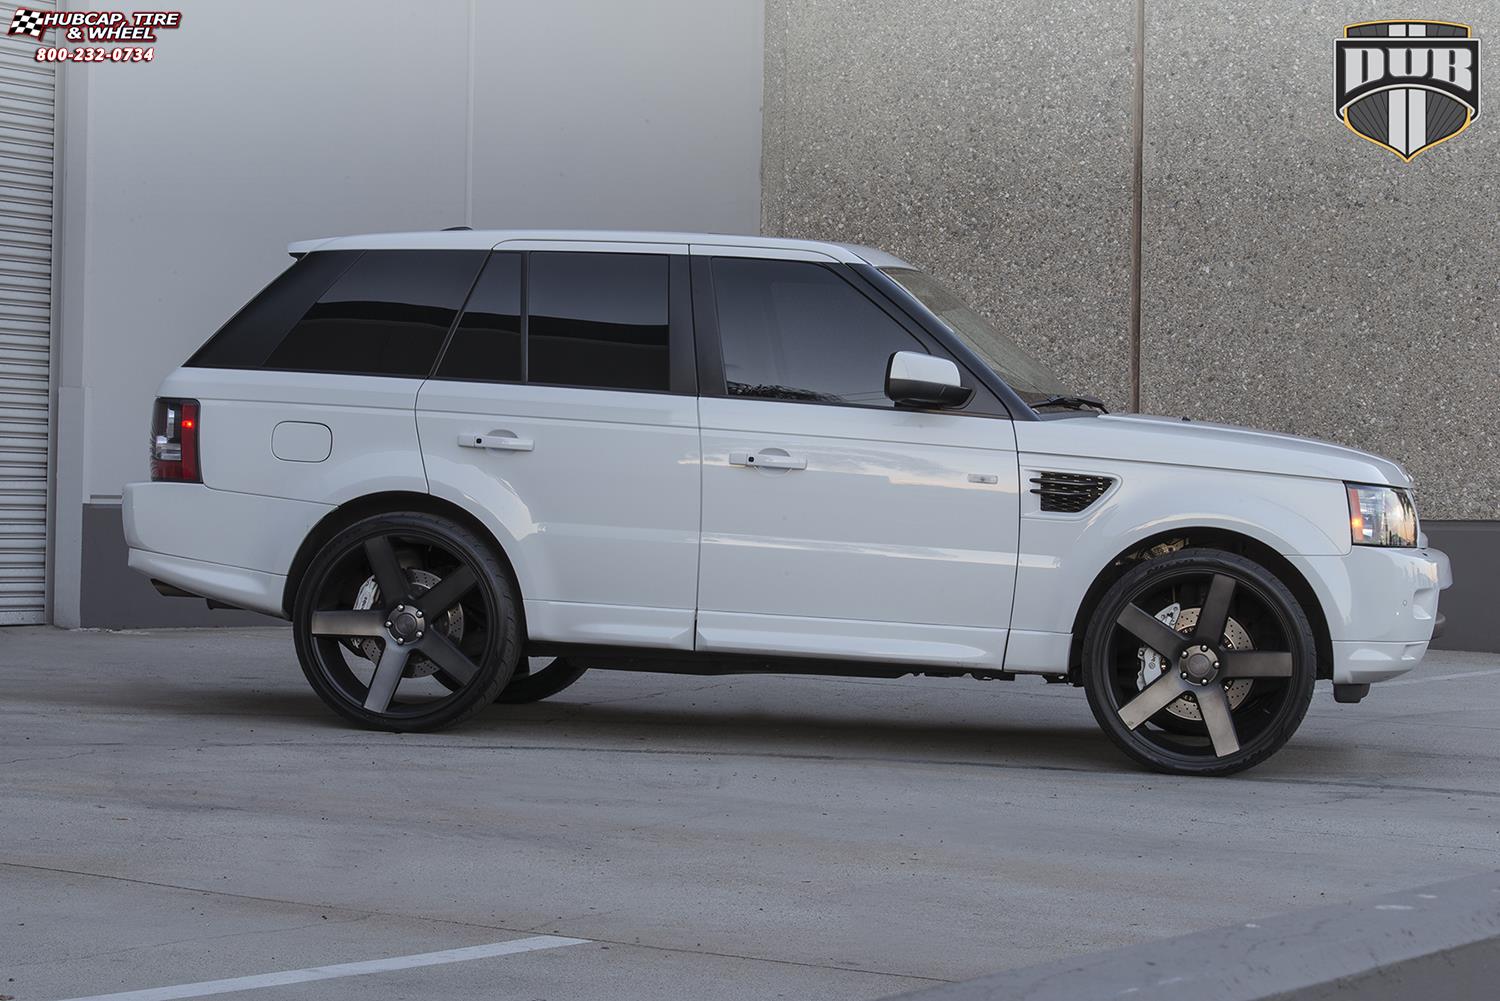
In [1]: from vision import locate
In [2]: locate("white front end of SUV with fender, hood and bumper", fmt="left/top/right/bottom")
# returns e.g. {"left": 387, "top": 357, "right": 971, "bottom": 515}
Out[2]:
{"left": 1007, "top": 416, "right": 1446, "bottom": 683}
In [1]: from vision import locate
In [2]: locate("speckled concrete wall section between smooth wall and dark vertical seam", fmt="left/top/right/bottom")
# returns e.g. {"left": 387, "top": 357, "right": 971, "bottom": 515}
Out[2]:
{"left": 761, "top": 0, "right": 1136, "bottom": 405}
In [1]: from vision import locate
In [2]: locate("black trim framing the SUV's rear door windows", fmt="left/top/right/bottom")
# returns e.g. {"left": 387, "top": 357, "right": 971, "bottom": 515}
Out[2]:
{"left": 428, "top": 243, "right": 698, "bottom": 396}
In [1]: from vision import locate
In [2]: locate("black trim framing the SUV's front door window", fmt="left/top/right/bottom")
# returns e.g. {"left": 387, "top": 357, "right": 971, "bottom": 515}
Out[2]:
{"left": 693, "top": 254, "right": 1019, "bottom": 420}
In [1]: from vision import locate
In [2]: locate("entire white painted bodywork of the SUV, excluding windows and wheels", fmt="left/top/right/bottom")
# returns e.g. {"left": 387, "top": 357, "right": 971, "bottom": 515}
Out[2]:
{"left": 125, "top": 231, "right": 1451, "bottom": 693}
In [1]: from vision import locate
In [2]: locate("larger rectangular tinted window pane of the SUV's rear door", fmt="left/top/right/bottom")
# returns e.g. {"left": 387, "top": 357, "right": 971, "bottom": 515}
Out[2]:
{"left": 527, "top": 254, "right": 671, "bottom": 392}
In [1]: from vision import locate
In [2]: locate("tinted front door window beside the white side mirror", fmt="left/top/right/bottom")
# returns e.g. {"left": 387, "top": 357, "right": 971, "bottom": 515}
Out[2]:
{"left": 713, "top": 257, "right": 926, "bottom": 407}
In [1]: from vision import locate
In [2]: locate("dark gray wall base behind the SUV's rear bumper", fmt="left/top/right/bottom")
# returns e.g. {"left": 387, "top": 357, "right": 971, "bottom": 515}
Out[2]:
{"left": 78, "top": 504, "right": 281, "bottom": 629}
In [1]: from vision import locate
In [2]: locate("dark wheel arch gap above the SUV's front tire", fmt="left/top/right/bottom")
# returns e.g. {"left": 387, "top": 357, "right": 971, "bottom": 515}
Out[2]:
{"left": 1068, "top": 527, "right": 1334, "bottom": 684}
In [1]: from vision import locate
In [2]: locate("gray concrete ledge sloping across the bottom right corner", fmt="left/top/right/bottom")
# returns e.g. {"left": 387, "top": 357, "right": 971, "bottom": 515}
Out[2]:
{"left": 882, "top": 873, "right": 1500, "bottom": 1001}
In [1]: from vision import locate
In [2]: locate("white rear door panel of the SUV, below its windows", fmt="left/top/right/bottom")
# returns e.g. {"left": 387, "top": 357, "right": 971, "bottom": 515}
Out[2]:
{"left": 417, "top": 380, "right": 699, "bottom": 648}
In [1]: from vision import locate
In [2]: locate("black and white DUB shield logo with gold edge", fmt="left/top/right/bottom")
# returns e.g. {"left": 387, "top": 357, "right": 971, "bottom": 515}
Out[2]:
{"left": 1334, "top": 21, "right": 1479, "bottom": 164}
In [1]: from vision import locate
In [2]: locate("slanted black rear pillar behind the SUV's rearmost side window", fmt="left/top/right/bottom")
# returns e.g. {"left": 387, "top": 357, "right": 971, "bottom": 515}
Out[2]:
{"left": 188, "top": 251, "right": 360, "bottom": 368}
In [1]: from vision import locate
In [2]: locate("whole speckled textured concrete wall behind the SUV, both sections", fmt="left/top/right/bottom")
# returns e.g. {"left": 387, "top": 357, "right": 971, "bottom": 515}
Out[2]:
{"left": 762, "top": 0, "right": 1500, "bottom": 519}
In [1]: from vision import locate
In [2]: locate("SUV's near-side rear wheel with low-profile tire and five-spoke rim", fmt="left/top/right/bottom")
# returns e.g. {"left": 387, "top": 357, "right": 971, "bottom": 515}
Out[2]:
{"left": 293, "top": 513, "right": 521, "bottom": 732}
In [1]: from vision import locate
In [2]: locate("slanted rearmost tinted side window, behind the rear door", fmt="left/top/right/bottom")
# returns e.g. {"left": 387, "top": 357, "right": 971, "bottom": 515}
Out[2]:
{"left": 266, "top": 251, "right": 485, "bottom": 377}
